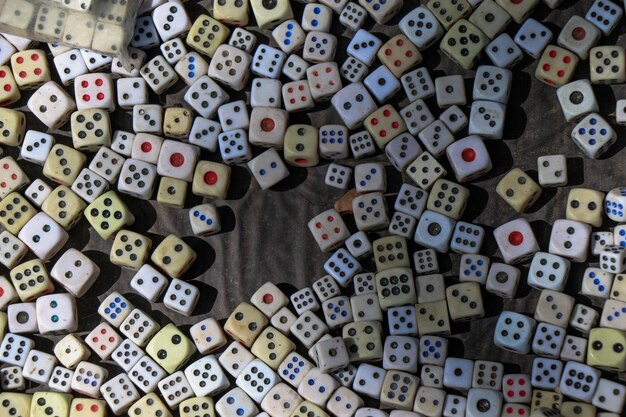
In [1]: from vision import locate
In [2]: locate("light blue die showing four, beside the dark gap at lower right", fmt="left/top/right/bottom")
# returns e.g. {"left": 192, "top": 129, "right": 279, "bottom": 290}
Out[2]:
{"left": 493, "top": 311, "right": 537, "bottom": 355}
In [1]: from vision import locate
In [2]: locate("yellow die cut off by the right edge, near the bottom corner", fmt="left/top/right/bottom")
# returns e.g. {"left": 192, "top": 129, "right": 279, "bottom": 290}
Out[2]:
{"left": 587, "top": 327, "right": 626, "bottom": 372}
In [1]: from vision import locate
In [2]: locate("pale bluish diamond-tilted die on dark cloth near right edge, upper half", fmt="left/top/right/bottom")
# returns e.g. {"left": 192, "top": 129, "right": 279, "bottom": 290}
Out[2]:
{"left": 571, "top": 113, "right": 617, "bottom": 159}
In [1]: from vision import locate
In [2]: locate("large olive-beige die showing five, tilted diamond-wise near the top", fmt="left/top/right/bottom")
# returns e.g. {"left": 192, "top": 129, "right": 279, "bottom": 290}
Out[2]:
{"left": 440, "top": 19, "right": 489, "bottom": 69}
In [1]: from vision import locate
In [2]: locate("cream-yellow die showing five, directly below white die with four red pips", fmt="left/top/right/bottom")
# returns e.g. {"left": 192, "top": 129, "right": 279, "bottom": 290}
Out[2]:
{"left": 70, "top": 109, "right": 111, "bottom": 152}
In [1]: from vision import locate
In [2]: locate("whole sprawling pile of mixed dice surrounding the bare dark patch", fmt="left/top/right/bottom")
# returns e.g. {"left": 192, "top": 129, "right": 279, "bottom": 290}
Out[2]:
{"left": 0, "top": 0, "right": 626, "bottom": 417}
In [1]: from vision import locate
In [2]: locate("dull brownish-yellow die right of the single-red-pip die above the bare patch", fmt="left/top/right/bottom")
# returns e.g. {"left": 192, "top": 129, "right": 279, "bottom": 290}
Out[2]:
{"left": 283, "top": 125, "right": 320, "bottom": 167}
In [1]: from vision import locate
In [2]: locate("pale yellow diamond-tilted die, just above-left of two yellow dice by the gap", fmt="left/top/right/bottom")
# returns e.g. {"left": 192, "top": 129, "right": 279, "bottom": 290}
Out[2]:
{"left": 85, "top": 191, "right": 135, "bottom": 240}
